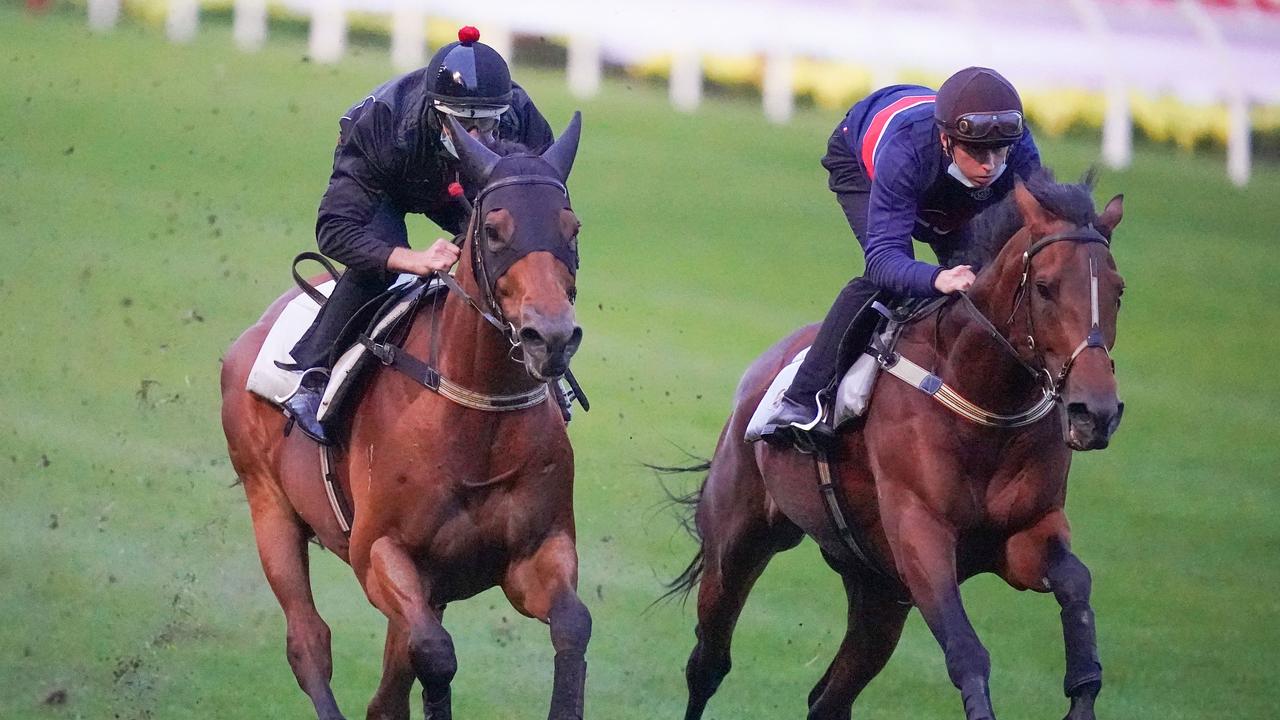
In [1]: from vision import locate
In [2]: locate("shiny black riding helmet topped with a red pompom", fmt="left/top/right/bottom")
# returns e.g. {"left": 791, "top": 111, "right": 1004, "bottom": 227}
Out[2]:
{"left": 424, "top": 26, "right": 511, "bottom": 118}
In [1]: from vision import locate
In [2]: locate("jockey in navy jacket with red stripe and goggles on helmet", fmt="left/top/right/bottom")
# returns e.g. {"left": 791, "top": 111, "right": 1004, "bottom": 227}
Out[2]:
{"left": 763, "top": 68, "right": 1041, "bottom": 442}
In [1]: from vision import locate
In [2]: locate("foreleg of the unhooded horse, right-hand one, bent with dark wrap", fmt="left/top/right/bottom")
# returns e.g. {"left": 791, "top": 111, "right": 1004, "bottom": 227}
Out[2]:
{"left": 1002, "top": 512, "right": 1102, "bottom": 720}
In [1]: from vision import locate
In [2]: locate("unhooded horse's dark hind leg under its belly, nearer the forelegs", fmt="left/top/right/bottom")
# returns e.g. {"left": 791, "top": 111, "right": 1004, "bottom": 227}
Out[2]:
{"left": 809, "top": 574, "right": 910, "bottom": 720}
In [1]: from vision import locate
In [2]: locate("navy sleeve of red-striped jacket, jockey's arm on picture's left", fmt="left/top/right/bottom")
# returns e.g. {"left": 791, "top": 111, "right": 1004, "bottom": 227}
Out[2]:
{"left": 863, "top": 137, "right": 942, "bottom": 297}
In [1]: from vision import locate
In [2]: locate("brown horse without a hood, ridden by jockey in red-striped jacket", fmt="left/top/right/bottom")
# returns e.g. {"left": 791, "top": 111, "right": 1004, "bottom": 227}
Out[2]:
{"left": 673, "top": 170, "right": 1123, "bottom": 720}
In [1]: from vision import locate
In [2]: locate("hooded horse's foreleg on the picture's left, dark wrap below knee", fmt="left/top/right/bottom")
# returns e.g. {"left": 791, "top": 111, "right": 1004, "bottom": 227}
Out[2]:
{"left": 364, "top": 537, "right": 458, "bottom": 720}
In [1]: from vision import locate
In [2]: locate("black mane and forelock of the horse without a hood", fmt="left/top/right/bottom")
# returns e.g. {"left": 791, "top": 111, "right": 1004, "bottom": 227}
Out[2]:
{"left": 955, "top": 168, "right": 1098, "bottom": 266}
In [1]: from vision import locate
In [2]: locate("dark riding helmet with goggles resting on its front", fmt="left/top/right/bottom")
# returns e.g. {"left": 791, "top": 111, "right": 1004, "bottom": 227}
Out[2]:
{"left": 933, "top": 67, "right": 1023, "bottom": 147}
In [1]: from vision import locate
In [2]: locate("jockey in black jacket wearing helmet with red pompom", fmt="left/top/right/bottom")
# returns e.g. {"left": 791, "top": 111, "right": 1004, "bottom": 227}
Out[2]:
{"left": 284, "top": 26, "right": 554, "bottom": 443}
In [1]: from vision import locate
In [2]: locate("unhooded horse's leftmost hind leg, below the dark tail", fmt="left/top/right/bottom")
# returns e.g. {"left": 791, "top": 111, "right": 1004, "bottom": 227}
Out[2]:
{"left": 685, "top": 442, "right": 803, "bottom": 720}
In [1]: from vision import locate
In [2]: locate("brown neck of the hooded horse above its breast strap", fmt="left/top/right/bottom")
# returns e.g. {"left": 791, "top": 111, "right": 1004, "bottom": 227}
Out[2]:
{"left": 412, "top": 246, "right": 538, "bottom": 395}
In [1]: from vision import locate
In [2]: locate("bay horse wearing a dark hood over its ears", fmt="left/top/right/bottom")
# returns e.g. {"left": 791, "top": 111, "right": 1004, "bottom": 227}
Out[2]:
{"left": 221, "top": 114, "right": 591, "bottom": 720}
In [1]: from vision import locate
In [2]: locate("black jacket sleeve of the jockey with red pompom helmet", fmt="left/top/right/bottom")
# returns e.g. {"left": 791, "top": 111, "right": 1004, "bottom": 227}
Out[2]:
{"left": 316, "top": 99, "right": 396, "bottom": 272}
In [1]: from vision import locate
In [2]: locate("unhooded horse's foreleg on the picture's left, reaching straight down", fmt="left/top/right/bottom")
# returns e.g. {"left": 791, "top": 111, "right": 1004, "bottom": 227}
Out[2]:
{"left": 881, "top": 488, "right": 996, "bottom": 720}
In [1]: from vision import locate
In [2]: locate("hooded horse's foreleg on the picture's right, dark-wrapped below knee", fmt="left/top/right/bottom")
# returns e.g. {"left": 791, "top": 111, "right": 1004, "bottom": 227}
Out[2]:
{"left": 503, "top": 534, "right": 591, "bottom": 720}
